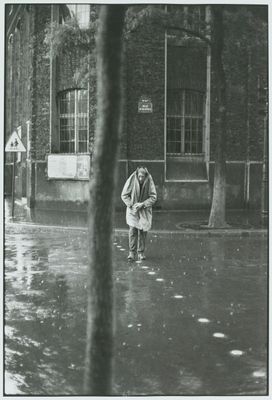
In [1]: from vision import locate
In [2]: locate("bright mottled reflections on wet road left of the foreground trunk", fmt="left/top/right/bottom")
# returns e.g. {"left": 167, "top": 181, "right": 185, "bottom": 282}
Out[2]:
{"left": 5, "top": 231, "right": 85, "bottom": 395}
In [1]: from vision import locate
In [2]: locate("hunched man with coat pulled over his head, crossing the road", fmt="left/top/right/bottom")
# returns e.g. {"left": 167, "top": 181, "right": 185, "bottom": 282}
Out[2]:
{"left": 121, "top": 167, "right": 157, "bottom": 260}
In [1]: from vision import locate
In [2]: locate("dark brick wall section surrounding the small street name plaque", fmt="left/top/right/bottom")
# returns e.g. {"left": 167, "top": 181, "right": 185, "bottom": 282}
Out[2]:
{"left": 126, "top": 24, "right": 165, "bottom": 160}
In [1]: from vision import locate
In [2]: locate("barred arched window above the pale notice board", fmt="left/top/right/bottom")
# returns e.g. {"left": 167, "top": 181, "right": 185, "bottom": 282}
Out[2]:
{"left": 59, "top": 90, "right": 88, "bottom": 153}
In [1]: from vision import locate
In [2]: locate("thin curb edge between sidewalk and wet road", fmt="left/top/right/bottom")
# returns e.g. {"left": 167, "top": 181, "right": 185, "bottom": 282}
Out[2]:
{"left": 5, "top": 222, "right": 268, "bottom": 237}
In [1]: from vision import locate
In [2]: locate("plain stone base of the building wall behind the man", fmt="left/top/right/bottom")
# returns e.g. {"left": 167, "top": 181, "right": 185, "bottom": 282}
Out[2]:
{"left": 5, "top": 160, "right": 262, "bottom": 211}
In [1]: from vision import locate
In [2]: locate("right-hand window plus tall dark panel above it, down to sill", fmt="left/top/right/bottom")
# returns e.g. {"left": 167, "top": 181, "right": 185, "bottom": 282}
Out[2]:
{"left": 166, "top": 43, "right": 207, "bottom": 156}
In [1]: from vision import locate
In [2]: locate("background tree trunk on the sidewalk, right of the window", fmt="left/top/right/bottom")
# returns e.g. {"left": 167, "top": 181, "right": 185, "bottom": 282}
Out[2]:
{"left": 209, "top": 5, "right": 227, "bottom": 228}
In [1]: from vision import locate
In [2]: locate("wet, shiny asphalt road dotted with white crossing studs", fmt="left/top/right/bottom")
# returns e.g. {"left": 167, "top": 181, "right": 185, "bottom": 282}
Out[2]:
{"left": 5, "top": 224, "right": 267, "bottom": 395}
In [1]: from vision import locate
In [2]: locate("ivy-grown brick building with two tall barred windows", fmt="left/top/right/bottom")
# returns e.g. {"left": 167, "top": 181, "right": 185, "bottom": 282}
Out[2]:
{"left": 5, "top": 4, "right": 267, "bottom": 209}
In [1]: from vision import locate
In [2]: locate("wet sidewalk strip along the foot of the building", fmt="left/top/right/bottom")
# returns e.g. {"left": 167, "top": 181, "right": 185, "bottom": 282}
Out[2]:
{"left": 5, "top": 198, "right": 268, "bottom": 235}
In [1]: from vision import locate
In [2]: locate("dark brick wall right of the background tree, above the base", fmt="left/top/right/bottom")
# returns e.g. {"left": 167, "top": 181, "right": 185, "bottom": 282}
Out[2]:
{"left": 211, "top": 8, "right": 267, "bottom": 160}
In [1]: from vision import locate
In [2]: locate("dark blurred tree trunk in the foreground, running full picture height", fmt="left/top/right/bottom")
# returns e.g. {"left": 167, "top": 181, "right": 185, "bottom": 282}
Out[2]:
{"left": 84, "top": 5, "right": 125, "bottom": 395}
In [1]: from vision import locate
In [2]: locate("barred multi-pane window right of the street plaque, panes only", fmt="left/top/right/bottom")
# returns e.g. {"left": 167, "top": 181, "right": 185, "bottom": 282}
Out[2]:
{"left": 166, "top": 89, "right": 204, "bottom": 156}
